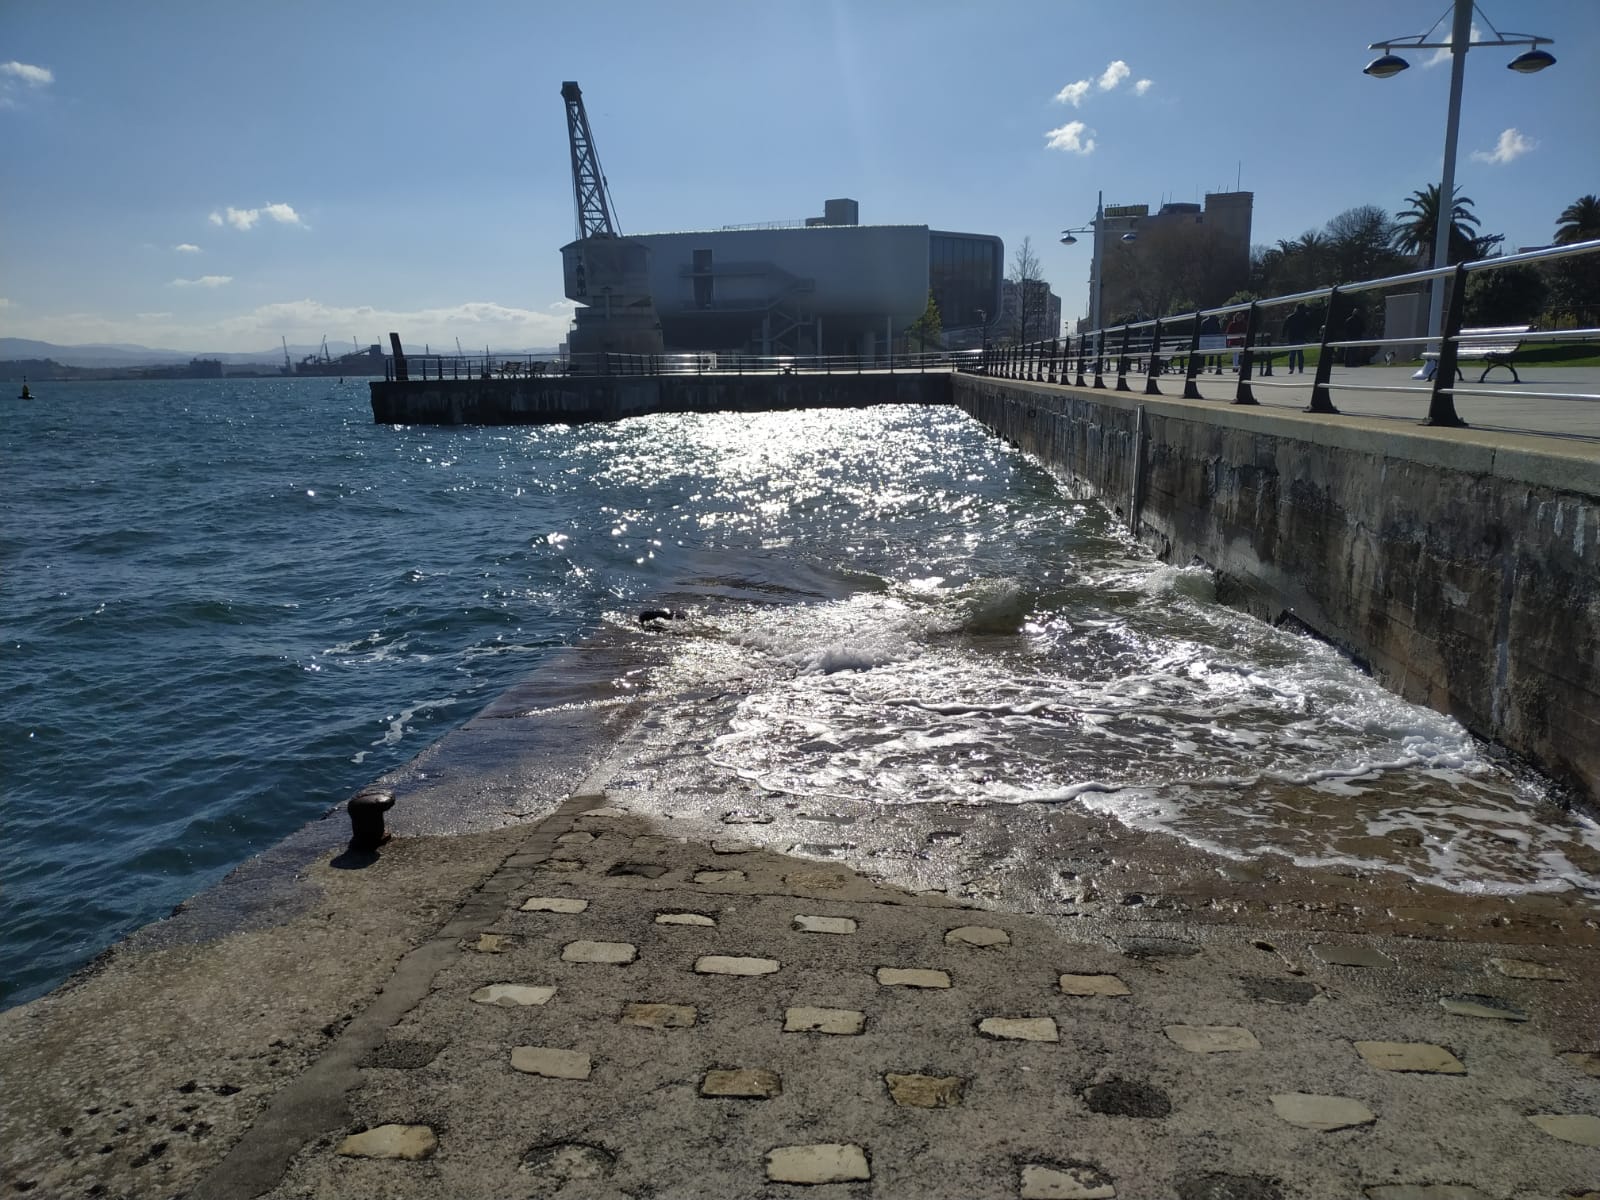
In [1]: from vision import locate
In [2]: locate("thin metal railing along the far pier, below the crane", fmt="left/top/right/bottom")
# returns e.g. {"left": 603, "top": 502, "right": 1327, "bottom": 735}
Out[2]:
{"left": 384, "top": 350, "right": 982, "bottom": 381}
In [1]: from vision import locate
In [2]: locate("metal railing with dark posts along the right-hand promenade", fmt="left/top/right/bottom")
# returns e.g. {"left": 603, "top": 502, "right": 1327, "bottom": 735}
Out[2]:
{"left": 962, "top": 240, "right": 1600, "bottom": 426}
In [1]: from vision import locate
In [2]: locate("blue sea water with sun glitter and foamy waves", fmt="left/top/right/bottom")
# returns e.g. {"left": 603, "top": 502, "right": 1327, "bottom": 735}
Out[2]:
{"left": 0, "top": 379, "right": 1600, "bottom": 1003}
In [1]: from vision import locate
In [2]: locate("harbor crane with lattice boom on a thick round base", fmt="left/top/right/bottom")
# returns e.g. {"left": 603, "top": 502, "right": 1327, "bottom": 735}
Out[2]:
{"left": 562, "top": 80, "right": 664, "bottom": 354}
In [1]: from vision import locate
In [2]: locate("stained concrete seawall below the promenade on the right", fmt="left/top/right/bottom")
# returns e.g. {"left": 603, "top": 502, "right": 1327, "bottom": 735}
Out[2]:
{"left": 954, "top": 376, "right": 1600, "bottom": 811}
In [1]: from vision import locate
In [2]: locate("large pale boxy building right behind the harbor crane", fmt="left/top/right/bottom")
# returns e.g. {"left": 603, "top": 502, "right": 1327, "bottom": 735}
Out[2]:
{"left": 611, "top": 198, "right": 1005, "bottom": 357}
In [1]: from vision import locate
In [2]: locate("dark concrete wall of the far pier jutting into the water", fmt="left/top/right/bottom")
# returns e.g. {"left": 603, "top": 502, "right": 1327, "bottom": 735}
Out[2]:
{"left": 370, "top": 371, "right": 950, "bottom": 426}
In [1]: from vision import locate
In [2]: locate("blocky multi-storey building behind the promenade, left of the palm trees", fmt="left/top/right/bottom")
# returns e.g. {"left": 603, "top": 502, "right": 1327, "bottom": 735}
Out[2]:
{"left": 1090, "top": 192, "right": 1254, "bottom": 325}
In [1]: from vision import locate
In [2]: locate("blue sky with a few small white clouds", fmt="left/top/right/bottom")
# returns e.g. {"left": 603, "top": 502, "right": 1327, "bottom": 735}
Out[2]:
{"left": 0, "top": 0, "right": 1600, "bottom": 352}
